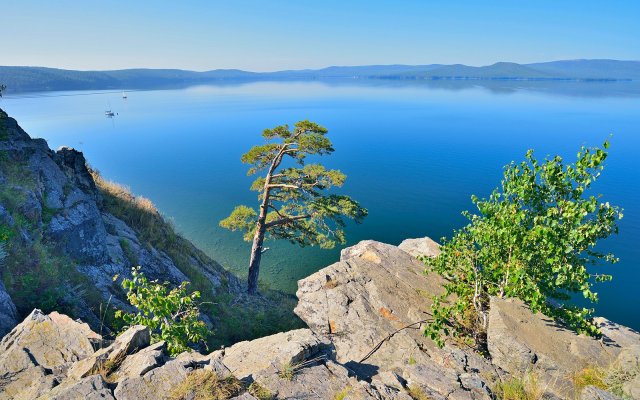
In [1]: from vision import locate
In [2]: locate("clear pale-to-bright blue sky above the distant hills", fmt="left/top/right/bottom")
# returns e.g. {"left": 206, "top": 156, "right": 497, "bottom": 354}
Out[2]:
{"left": 0, "top": 0, "right": 640, "bottom": 71}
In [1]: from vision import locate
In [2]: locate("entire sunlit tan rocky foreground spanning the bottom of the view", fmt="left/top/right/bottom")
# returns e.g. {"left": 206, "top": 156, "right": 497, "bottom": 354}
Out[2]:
{"left": 0, "top": 239, "right": 640, "bottom": 400}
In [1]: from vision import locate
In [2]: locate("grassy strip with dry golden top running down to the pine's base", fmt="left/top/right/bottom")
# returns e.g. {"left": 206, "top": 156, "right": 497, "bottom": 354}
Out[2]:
{"left": 93, "top": 172, "right": 303, "bottom": 348}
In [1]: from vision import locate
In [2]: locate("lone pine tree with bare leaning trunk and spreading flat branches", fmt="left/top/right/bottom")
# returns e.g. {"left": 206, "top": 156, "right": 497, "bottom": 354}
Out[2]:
{"left": 220, "top": 120, "right": 367, "bottom": 294}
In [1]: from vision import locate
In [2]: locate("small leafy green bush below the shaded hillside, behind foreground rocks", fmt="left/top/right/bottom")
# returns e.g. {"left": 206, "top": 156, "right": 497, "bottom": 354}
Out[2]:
{"left": 116, "top": 267, "right": 209, "bottom": 355}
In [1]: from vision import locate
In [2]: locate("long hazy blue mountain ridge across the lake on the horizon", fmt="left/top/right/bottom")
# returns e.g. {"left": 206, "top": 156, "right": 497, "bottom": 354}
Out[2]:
{"left": 0, "top": 59, "right": 640, "bottom": 93}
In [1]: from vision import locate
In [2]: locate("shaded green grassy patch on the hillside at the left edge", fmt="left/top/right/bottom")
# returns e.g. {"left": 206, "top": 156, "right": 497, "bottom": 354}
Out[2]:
{"left": 0, "top": 110, "right": 103, "bottom": 323}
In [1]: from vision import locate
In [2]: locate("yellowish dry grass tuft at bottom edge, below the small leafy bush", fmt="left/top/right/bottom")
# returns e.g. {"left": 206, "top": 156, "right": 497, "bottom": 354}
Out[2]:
{"left": 170, "top": 369, "right": 243, "bottom": 400}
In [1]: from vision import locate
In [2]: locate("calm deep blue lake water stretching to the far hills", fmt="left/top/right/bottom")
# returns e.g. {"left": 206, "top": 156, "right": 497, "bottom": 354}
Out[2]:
{"left": 0, "top": 82, "right": 640, "bottom": 329}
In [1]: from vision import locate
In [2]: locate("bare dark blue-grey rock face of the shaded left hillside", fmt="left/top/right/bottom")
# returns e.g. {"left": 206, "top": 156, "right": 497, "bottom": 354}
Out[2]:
{"left": 0, "top": 105, "right": 242, "bottom": 336}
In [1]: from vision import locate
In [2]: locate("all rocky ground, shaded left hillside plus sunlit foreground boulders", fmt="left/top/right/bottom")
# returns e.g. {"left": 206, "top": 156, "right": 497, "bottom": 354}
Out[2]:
{"left": 0, "top": 110, "right": 640, "bottom": 400}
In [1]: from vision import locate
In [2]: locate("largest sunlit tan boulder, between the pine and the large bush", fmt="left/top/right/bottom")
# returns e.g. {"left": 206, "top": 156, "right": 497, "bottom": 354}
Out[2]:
{"left": 295, "top": 240, "right": 493, "bottom": 399}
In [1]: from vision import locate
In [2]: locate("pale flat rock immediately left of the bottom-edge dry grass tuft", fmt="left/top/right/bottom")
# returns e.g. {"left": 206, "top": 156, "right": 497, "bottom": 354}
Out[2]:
{"left": 114, "top": 353, "right": 231, "bottom": 400}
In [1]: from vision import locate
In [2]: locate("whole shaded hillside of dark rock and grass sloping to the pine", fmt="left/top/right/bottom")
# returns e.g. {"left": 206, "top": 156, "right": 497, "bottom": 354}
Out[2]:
{"left": 0, "top": 110, "right": 300, "bottom": 345}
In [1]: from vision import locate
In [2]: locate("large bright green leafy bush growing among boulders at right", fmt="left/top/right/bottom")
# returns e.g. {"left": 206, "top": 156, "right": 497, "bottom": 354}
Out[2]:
{"left": 424, "top": 142, "right": 622, "bottom": 346}
